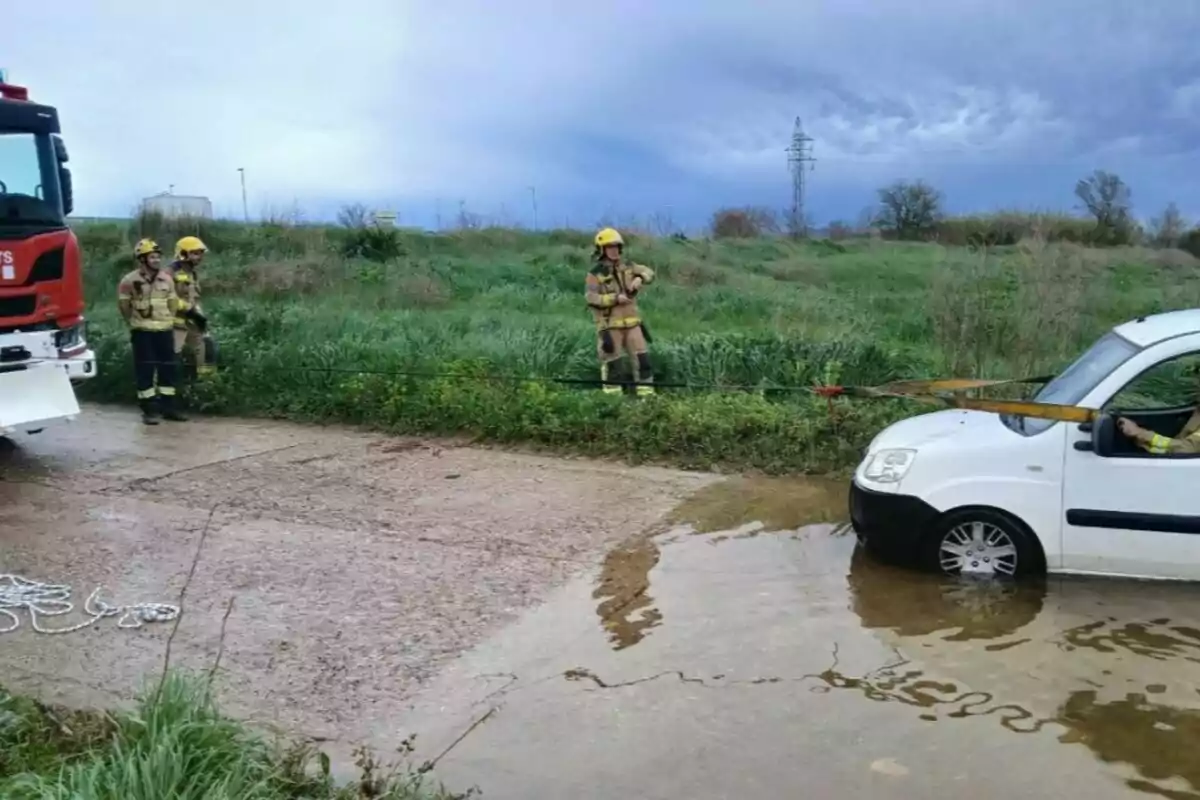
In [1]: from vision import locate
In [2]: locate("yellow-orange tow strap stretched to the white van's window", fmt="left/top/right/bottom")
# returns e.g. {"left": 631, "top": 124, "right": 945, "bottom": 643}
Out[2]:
{"left": 816, "top": 377, "right": 1100, "bottom": 422}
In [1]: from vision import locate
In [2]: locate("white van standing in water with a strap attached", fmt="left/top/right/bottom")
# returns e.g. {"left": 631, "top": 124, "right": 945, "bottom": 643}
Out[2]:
{"left": 850, "top": 309, "right": 1200, "bottom": 579}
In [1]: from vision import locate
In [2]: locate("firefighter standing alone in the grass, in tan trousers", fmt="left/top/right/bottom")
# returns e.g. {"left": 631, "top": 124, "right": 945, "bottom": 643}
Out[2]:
{"left": 587, "top": 228, "right": 654, "bottom": 396}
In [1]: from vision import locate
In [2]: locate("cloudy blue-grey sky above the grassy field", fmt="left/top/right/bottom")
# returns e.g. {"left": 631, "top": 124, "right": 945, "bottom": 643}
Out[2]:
{"left": 9, "top": 0, "right": 1200, "bottom": 225}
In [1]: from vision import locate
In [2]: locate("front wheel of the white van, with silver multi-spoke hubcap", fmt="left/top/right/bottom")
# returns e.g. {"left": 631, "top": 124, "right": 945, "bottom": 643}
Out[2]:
{"left": 922, "top": 509, "right": 1042, "bottom": 578}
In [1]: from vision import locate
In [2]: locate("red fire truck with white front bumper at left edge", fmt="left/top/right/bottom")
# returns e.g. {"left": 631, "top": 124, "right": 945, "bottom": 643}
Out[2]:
{"left": 0, "top": 71, "right": 96, "bottom": 437}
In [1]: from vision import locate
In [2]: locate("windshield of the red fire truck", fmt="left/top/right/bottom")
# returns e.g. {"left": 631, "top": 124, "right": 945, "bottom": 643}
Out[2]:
{"left": 0, "top": 131, "right": 64, "bottom": 228}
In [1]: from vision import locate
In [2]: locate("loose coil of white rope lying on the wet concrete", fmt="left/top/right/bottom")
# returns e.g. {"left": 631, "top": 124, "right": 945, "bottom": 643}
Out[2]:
{"left": 0, "top": 573, "right": 179, "bottom": 633}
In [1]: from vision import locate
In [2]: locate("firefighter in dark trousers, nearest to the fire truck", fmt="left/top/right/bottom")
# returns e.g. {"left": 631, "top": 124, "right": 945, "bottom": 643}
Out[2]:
{"left": 116, "top": 239, "right": 186, "bottom": 425}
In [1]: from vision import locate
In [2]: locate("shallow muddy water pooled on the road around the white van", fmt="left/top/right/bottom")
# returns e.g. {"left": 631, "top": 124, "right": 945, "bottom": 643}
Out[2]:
{"left": 396, "top": 479, "right": 1200, "bottom": 798}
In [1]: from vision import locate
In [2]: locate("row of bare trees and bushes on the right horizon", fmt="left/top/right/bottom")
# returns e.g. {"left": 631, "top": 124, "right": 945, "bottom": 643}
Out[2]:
{"left": 710, "top": 169, "right": 1200, "bottom": 258}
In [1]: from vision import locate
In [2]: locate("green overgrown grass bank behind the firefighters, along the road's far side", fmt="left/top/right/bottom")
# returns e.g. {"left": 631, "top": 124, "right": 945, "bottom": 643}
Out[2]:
{"left": 72, "top": 214, "right": 1200, "bottom": 471}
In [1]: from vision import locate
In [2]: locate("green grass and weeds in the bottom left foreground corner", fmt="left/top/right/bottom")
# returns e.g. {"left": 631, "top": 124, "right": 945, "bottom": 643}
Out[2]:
{"left": 0, "top": 673, "right": 475, "bottom": 800}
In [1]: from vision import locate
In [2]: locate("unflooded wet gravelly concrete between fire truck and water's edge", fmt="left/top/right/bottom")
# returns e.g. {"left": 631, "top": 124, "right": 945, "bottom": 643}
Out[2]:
{"left": 0, "top": 408, "right": 713, "bottom": 740}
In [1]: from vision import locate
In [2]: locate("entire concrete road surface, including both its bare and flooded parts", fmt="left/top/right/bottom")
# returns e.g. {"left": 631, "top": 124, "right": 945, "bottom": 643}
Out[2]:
{"left": 0, "top": 409, "right": 1200, "bottom": 800}
